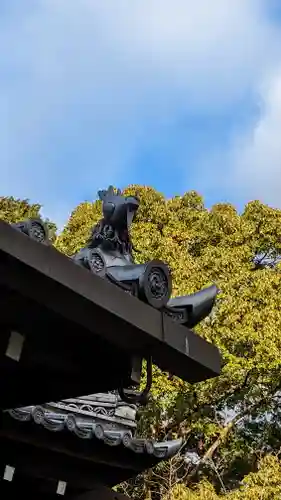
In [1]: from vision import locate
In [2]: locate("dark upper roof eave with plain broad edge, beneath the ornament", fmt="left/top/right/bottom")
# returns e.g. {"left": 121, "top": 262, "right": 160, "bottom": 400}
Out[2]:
{"left": 0, "top": 220, "right": 221, "bottom": 409}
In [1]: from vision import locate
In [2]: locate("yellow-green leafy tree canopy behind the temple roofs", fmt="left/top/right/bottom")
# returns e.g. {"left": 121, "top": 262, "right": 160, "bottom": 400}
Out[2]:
{"left": 0, "top": 185, "right": 281, "bottom": 500}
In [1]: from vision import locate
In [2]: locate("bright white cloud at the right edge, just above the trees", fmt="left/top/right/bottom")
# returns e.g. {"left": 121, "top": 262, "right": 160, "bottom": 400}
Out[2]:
{"left": 230, "top": 70, "right": 281, "bottom": 208}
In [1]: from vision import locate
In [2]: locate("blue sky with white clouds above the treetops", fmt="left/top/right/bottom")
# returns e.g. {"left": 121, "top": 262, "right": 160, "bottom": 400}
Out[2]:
{"left": 0, "top": 0, "right": 281, "bottom": 227}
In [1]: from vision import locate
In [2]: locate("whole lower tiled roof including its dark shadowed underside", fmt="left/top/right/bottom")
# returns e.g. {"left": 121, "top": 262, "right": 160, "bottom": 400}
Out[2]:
{"left": 0, "top": 392, "right": 182, "bottom": 491}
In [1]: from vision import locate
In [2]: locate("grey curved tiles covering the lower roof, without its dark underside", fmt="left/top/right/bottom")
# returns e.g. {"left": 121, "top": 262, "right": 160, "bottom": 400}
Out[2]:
{"left": 5, "top": 395, "right": 182, "bottom": 460}
